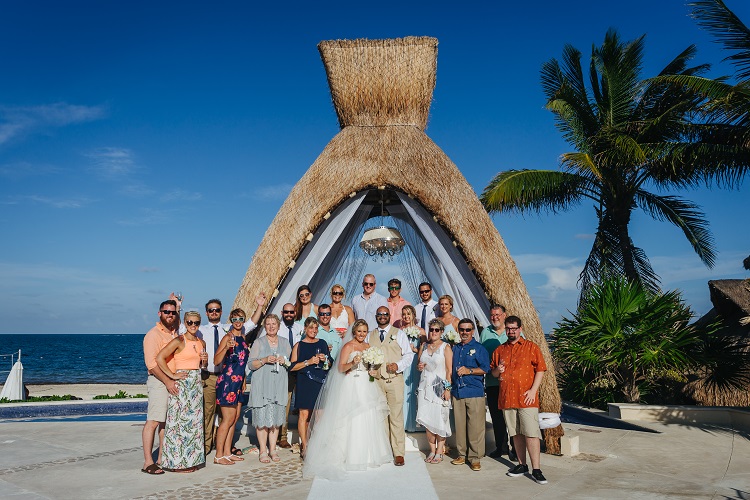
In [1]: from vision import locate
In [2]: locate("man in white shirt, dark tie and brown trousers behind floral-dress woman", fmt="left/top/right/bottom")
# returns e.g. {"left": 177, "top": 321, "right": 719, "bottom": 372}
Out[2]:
{"left": 185, "top": 293, "right": 266, "bottom": 455}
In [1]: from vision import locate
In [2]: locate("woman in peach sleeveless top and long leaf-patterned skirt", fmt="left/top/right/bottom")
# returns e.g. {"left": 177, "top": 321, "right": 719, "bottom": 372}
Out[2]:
{"left": 156, "top": 311, "right": 208, "bottom": 472}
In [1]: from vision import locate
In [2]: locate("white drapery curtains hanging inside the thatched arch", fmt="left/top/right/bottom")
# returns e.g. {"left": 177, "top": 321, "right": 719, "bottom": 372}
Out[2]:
{"left": 269, "top": 191, "right": 489, "bottom": 334}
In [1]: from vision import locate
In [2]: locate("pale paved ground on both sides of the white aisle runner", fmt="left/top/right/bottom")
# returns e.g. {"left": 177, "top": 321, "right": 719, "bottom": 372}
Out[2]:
{"left": 0, "top": 413, "right": 750, "bottom": 500}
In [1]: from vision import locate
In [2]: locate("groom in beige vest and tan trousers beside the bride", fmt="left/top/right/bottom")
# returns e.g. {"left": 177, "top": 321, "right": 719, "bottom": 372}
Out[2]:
{"left": 368, "top": 306, "right": 414, "bottom": 465}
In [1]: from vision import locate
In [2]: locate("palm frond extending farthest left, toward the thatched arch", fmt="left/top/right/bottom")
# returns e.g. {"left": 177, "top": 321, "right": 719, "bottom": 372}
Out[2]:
{"left": 479, "top": 170, "right": 591, "bottom": 213}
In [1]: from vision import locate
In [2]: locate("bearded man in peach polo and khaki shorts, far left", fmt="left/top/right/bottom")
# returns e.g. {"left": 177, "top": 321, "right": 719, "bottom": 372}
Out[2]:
{"left": 141, "top": 300, "right": 180, "bottom": 475}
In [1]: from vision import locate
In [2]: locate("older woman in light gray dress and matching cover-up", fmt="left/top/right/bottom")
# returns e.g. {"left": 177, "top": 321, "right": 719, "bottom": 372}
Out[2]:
{"left": 250, "top": 314, "right": 292, "bottom": 464}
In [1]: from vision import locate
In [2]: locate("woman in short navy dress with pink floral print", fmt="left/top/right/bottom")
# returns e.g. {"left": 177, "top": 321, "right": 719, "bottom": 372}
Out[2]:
{"left": 214, "top": 309, "right": 248, "bottom": 465}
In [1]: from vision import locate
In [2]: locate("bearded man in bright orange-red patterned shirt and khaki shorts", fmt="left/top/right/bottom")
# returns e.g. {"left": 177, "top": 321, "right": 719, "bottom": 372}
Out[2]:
{"left": 490, "top": 316, "right": 547, "bottom": 484}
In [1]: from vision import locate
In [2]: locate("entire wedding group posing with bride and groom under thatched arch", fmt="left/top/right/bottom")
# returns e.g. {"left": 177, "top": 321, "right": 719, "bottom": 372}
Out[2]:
{"left": 142, "top": 274, "right": 546, "bottom": 484}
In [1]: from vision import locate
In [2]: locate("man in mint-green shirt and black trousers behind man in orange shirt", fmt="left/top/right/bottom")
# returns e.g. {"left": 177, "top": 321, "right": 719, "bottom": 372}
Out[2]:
{"left": 479, "top": 304, "right": 517, "bottom": 462}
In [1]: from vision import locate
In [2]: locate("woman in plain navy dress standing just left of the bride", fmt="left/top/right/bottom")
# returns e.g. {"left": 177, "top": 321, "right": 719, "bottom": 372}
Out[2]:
{"left": 289, "top": 318, "right": 333, "bottom": 458}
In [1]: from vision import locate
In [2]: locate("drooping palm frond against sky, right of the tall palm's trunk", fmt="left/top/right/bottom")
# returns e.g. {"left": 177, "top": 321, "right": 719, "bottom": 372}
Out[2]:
{"left": 636, "top": 189, "right": 716, "bottom": 268}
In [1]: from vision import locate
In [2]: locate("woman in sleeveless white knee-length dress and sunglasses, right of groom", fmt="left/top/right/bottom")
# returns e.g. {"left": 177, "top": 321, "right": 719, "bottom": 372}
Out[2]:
{"left": 417, "top": 319, "right": 453, "bottom": 464}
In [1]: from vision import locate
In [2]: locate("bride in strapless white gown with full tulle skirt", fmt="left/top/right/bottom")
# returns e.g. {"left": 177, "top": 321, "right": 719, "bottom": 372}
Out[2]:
{"left": 302, "top": 320, "right": 393, "bottom": 479}
